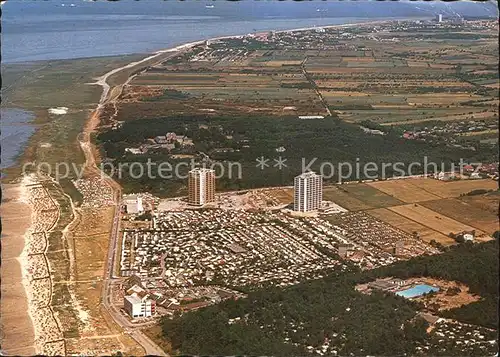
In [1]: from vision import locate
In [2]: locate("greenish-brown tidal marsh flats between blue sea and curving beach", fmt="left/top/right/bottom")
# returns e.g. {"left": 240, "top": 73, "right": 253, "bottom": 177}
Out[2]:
{"left": 2, "top": 54, "right": 145, "bottom": 182}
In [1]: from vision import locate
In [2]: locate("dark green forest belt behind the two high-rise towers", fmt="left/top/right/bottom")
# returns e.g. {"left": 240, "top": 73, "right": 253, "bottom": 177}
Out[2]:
{"left": 97, "top": 115, "right": 497, "bottom": 197}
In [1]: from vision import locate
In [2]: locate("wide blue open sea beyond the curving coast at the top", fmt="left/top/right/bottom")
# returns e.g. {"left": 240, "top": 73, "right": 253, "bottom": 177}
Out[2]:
{"left": 2, "top": 0, "right": 422, "bottom": 63}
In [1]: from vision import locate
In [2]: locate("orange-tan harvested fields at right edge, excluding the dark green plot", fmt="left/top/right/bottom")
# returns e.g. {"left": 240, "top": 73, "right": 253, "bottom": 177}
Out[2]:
{"left": 367, "top": 178, "right": 499, "bottom": 245}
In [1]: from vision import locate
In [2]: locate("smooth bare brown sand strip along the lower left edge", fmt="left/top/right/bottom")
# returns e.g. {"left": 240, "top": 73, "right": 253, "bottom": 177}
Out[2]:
{"left": 1, "top": 183, "right": 36, "bottom": 355}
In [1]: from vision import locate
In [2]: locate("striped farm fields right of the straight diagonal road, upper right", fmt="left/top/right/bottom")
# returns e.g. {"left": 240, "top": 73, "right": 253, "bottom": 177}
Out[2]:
{"left": 305, "top": 26, "right": 498, "bottom": 125}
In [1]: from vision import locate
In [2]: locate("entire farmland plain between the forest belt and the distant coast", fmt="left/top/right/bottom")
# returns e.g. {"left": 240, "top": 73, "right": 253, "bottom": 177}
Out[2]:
{"left": 112, "top": 22, "right": 498, "bottom": 125}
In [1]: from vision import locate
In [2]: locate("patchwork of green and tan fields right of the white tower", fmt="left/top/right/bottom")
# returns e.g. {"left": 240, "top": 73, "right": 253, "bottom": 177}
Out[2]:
{"left": 323, "top": 178, "right": 500, "bottom": 246}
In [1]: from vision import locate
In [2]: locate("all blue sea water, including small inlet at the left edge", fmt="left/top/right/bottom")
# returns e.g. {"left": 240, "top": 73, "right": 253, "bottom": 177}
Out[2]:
{"left": 0, "top": 0, "right": 496, "bottom": 168}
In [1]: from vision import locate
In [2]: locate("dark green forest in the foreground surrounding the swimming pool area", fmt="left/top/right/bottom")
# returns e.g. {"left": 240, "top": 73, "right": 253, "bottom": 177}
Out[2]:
{"left": 162, "top": 240, "right": 498, "bottom": 356}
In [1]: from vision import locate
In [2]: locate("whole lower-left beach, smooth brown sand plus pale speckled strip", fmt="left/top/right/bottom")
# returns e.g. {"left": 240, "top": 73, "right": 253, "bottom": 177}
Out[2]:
{"left": 1, "top": 176, "right": 64, "bottom": 355}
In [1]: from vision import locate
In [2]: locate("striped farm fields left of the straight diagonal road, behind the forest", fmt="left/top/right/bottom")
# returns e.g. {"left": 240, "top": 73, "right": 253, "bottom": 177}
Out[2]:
{"left": 119, "top": 51, "right": 326, "bottom": 120}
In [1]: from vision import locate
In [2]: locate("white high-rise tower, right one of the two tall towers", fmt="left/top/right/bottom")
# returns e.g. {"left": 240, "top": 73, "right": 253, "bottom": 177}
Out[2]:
{"left": 293, "top": 171, "right": 323, "bottom": 212}
